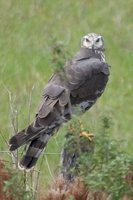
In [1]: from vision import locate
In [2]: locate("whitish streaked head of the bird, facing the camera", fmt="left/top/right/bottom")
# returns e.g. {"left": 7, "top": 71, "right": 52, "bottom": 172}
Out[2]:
{"left": 81, "top": 33, "right": 104, "bottom": 51}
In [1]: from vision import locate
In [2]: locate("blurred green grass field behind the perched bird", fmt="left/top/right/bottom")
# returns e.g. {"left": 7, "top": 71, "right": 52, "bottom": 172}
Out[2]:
{"left": 0, "top": 0, "right": 133, "bottom": 188}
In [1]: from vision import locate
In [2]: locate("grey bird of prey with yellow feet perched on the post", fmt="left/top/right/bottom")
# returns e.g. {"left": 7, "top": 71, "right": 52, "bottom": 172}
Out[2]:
{"left": 9, "top": 33, "right": 110, "bottom": 171}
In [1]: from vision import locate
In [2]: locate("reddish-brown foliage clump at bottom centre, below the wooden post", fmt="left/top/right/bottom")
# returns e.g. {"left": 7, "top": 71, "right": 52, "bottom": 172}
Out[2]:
{"left": 41, "top": 176, "right": 133, "bottom": 200}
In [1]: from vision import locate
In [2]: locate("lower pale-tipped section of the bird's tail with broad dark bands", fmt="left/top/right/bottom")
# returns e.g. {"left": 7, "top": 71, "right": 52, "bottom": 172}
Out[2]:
{"left": 19, "top": 134, "right": 51, "bottom": 171}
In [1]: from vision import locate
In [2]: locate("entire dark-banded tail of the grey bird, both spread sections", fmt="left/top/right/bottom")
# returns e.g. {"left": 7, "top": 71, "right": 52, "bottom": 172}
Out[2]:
{"left": 9, "top": 114, "right": 65, "bottom": 171}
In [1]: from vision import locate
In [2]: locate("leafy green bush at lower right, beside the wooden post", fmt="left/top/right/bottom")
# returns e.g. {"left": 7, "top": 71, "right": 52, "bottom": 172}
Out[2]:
{"left": 78, "top": 117, "right": 133, "bottom": 200}
